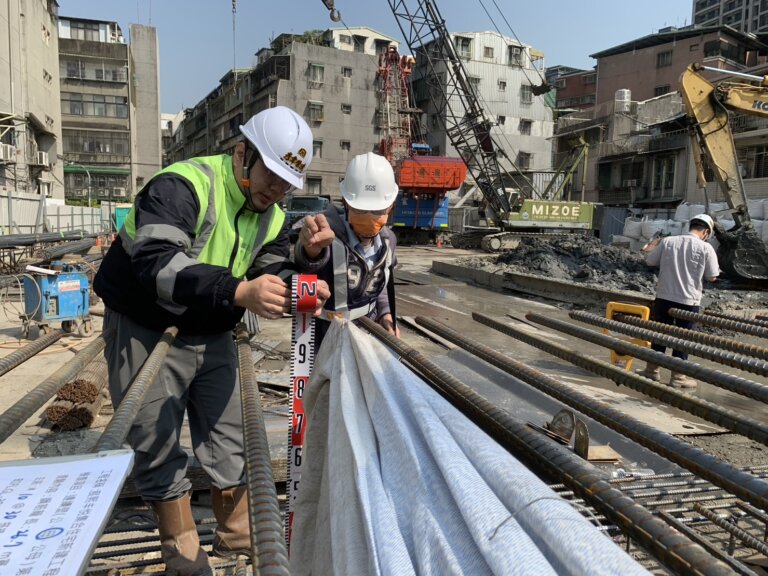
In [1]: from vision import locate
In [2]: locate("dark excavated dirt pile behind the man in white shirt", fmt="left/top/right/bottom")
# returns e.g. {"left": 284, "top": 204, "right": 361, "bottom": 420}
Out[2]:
{"left": 460, "top": 236, "right": 768, "bottom": 311}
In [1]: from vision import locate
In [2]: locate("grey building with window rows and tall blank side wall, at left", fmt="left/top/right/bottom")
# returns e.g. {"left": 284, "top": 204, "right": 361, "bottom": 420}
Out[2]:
{"left": 58, "top": 16, "right": 162, "bottom": 204}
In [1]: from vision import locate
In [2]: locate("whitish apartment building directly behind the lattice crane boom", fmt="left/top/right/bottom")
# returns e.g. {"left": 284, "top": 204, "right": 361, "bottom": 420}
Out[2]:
{"left": 412, "top": 32, "right": 554, "bottom": 192}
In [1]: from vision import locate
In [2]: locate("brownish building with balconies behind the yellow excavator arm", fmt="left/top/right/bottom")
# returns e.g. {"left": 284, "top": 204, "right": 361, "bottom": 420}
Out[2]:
{"left": 556, "top": 27, "right": 768, "bottom": 208}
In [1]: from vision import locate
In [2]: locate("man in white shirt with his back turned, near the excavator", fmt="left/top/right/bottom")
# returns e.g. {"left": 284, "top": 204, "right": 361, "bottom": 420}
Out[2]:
{"left": 639, "top": 214, "right": 720, "bottom": 388}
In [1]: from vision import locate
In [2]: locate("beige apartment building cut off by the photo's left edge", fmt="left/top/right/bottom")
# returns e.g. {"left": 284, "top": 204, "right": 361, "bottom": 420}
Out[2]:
{"left": 0, "top": 0, "right": 64, "bottom": 202}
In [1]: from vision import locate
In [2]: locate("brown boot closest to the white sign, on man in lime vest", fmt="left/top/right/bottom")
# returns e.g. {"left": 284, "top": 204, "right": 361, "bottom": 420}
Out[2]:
{"left": 150, "top": 494, "right": 213, "bottom": 576}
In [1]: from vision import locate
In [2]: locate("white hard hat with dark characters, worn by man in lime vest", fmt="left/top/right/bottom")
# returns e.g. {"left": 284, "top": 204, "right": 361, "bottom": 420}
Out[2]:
{"left": 240, "top": 106, "right": 312, "bottom": 188}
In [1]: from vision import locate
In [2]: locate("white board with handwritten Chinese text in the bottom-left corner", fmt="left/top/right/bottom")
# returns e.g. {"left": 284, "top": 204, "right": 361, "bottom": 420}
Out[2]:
{"left": 0, "top": 450, "right": 133, "bottom": 576}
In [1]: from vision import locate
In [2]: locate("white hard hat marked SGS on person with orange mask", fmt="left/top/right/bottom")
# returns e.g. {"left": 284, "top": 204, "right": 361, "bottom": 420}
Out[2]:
{"left": 339, "top": 152, "right": 397, "bottom": 210}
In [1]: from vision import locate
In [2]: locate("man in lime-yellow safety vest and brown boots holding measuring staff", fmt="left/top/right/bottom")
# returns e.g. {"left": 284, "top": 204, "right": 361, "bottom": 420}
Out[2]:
{"left": 94, "top": 106, "right": 330, "bottom": 576}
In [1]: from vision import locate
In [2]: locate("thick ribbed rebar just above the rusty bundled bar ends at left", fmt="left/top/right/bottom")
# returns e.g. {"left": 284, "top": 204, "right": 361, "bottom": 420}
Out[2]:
{"left": 0, "top": 332, "right": 109, "bottom": 442}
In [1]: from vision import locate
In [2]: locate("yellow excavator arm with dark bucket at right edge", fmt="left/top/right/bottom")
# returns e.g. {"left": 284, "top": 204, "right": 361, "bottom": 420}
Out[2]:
{"left": 680, "top": 64, "right": 768, "bottom": 280}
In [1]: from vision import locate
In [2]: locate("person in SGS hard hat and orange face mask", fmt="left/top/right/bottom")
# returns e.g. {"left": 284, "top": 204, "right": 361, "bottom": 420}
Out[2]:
{"left": 295, "top": 152, "right": 400, "bottom": 347}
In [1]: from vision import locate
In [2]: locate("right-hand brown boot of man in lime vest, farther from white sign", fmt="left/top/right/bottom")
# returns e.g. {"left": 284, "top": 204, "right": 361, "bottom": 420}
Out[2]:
{"left": 211, "top": 486, "right": 251, "bottom": 559}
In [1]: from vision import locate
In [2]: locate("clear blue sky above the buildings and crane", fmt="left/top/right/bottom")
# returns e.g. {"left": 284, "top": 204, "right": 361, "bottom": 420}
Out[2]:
{"left": 58, "top": 0, "right": 692, "bottom": 113}
